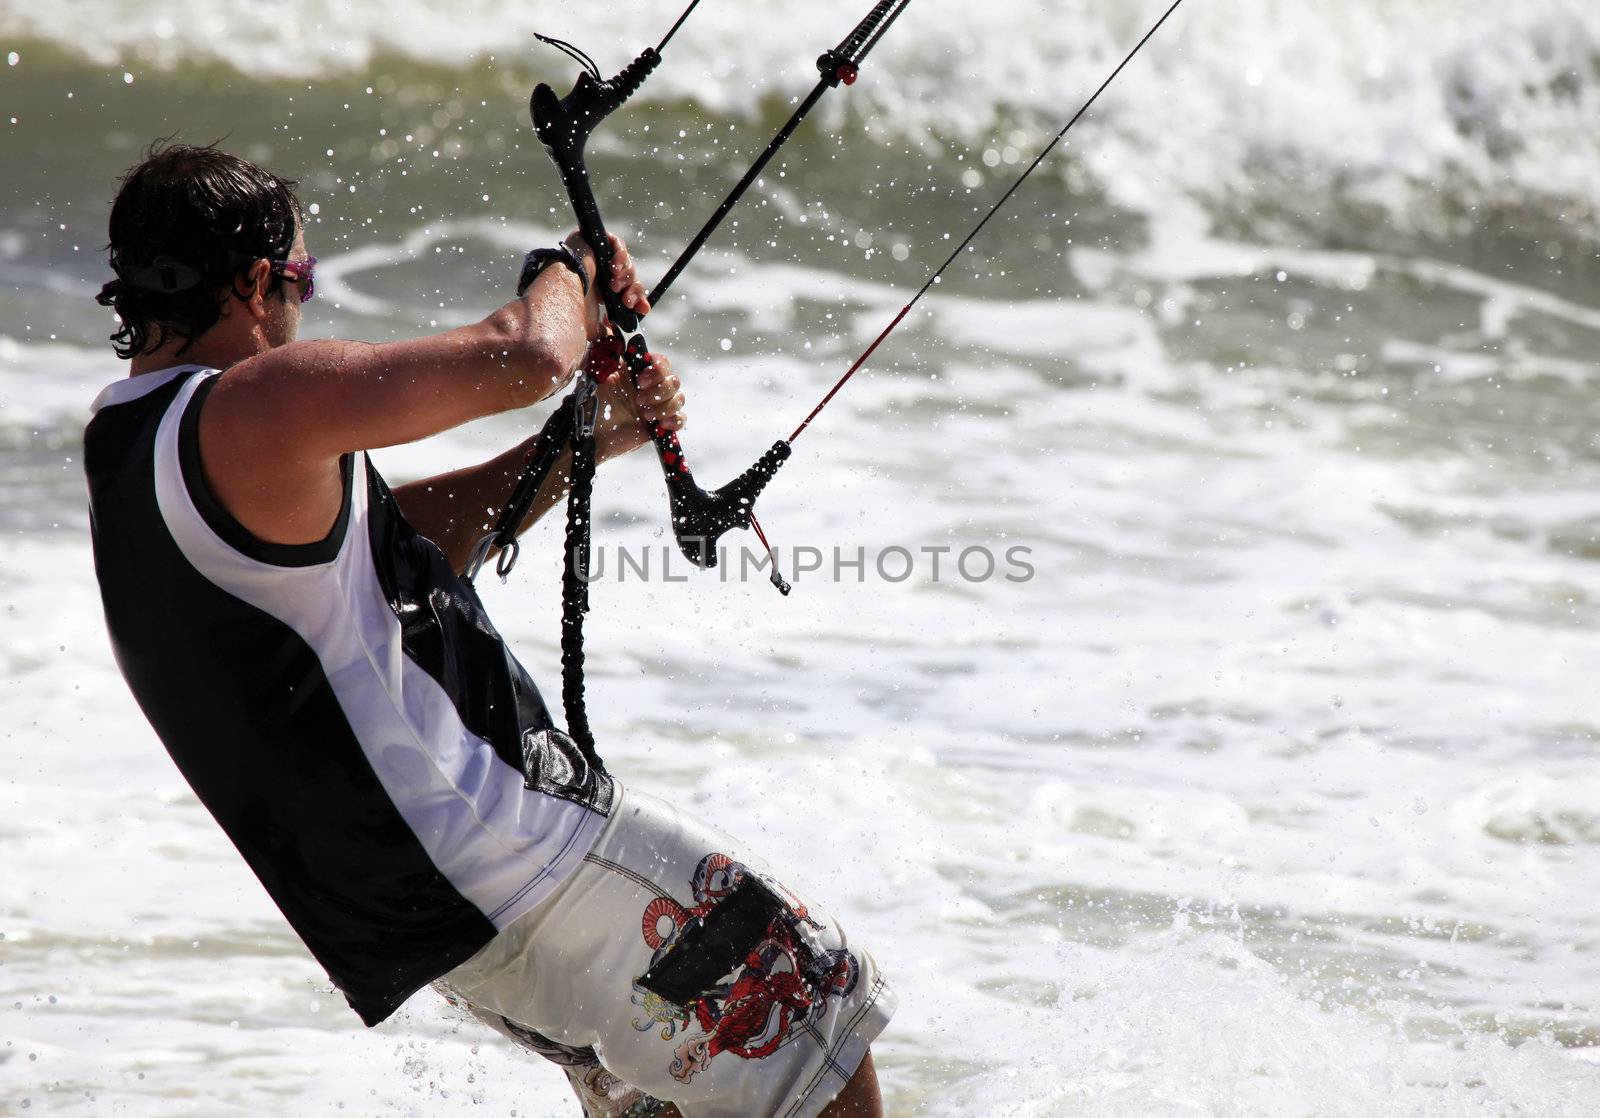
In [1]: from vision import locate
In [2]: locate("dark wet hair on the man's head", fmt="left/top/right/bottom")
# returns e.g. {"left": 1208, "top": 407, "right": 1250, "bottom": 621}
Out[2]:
{"left": 94, "top": 141, "right": 301, "bottom": 358}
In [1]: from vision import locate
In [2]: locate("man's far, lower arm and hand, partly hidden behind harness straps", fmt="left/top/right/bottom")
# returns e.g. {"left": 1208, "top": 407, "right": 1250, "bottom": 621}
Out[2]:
{"left": 394, "top": 344, "right": 686, "bottom": 571}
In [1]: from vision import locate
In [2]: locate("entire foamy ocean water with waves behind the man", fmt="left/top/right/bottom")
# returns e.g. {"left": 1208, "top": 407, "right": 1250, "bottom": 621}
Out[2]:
{"left": 0, "top": 0, "right": 1600, "bottom": 1118}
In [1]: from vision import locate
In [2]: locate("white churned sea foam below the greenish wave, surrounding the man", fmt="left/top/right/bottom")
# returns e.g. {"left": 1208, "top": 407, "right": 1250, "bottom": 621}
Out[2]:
{"left": 0, "top": 111, "right": 1600, "bottom": 1118}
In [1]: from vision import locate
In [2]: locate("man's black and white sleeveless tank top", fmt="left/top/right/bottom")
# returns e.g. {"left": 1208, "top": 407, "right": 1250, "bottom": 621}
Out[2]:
{"left": 83, "top": 366, "right": 613, "bottom": 1024}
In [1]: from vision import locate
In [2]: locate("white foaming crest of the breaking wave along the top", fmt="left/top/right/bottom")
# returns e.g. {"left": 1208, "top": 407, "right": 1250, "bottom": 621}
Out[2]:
{"left": 9, "top": 0, "right": 1600, "bottom": 242}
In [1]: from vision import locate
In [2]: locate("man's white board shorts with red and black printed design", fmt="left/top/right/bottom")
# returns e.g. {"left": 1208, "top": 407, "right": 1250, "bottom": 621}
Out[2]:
{"left": 435, "top": 785, "right": 896, "bottom": 1118}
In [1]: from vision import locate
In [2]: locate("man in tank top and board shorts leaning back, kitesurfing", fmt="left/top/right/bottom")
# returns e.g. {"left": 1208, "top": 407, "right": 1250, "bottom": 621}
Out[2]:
{"left": 85, "top": 146, "right": 893, "bottom": 1118}
